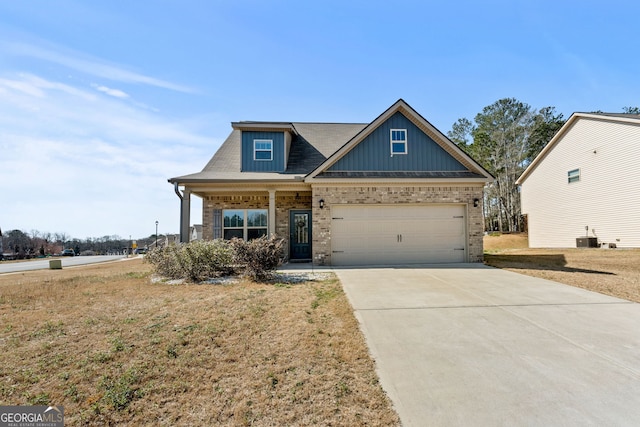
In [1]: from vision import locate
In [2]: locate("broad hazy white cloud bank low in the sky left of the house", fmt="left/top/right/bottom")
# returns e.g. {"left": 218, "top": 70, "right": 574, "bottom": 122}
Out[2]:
{"left": 0, "top": 74, "right": 215, "bottom": 238}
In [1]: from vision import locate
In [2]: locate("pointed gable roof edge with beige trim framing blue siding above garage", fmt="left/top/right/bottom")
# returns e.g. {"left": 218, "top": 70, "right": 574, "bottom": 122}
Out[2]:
{"left": 305, "top": 99, "right": 493, "bottom": 181}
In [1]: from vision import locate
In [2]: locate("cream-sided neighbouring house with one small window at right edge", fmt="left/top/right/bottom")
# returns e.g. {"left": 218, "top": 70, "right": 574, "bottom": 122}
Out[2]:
{"left": 516, "top": 113, "right": 640, "bottom": 248}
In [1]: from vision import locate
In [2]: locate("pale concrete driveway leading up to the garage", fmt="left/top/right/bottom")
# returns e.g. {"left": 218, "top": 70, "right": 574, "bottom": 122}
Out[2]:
{"left": 335, "top": 264, "right": 640, "bottom": 426}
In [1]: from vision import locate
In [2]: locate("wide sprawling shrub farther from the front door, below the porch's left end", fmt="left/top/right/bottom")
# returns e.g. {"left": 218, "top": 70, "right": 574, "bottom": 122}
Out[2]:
{"left": 145, "top": 239, "right": 234, "bottom": 282}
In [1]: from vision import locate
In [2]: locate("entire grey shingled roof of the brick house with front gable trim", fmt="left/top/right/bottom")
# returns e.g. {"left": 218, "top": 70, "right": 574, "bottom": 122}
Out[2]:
{"left": 169, "top": 99, "right": 493, "bottom": 184}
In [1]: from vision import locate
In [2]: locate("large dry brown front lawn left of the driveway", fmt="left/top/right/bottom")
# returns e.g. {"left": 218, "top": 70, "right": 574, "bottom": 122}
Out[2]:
{"left": 0, "top": 260, "right": 399, "bottom": 426}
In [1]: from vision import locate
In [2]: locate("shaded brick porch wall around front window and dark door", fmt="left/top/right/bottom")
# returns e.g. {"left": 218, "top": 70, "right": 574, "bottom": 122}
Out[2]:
{"left": 202, "top": 191, "right": 311, "bottom": 256}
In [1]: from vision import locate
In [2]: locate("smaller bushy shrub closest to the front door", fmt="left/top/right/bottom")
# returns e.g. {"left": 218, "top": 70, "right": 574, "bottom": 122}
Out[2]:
{"left": 231, "top": 236, "right": 284, "bottom": 280}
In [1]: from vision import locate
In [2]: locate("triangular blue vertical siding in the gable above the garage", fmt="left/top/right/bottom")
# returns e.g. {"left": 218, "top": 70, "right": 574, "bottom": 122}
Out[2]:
{"left": 327, "top": 112, "right": 467, "bottom": 172}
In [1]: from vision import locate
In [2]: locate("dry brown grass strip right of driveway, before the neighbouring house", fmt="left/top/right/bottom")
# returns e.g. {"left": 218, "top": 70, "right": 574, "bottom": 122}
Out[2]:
{"left": 484, "top": 234, "right": 640, "bottom": 302}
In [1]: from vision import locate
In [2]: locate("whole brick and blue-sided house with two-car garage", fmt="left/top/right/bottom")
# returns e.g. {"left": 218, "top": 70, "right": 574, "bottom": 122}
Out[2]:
{"left": 169, "top": 100, "right": 493, "bottom": 265}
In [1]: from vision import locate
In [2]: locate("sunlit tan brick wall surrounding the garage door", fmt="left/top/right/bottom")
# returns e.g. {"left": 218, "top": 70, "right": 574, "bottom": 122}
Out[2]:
{"left": 313, "top": 186, "right": 484, "bottom": 265}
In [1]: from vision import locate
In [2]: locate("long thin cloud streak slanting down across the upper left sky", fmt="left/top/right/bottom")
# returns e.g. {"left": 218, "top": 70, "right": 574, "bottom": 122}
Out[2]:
{"left": 0, "top": 41, "right": 195, "bottom": 93}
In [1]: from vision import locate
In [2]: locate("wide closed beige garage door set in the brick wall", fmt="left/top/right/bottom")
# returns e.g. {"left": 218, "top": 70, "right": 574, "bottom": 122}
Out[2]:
{"left": 331, "top": 205, "right": 467, "bottom": 265}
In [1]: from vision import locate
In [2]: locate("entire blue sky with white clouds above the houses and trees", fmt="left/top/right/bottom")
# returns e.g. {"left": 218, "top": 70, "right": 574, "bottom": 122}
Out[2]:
{"left": 0, "top": 0, "right": 640, "bottom": 239}
